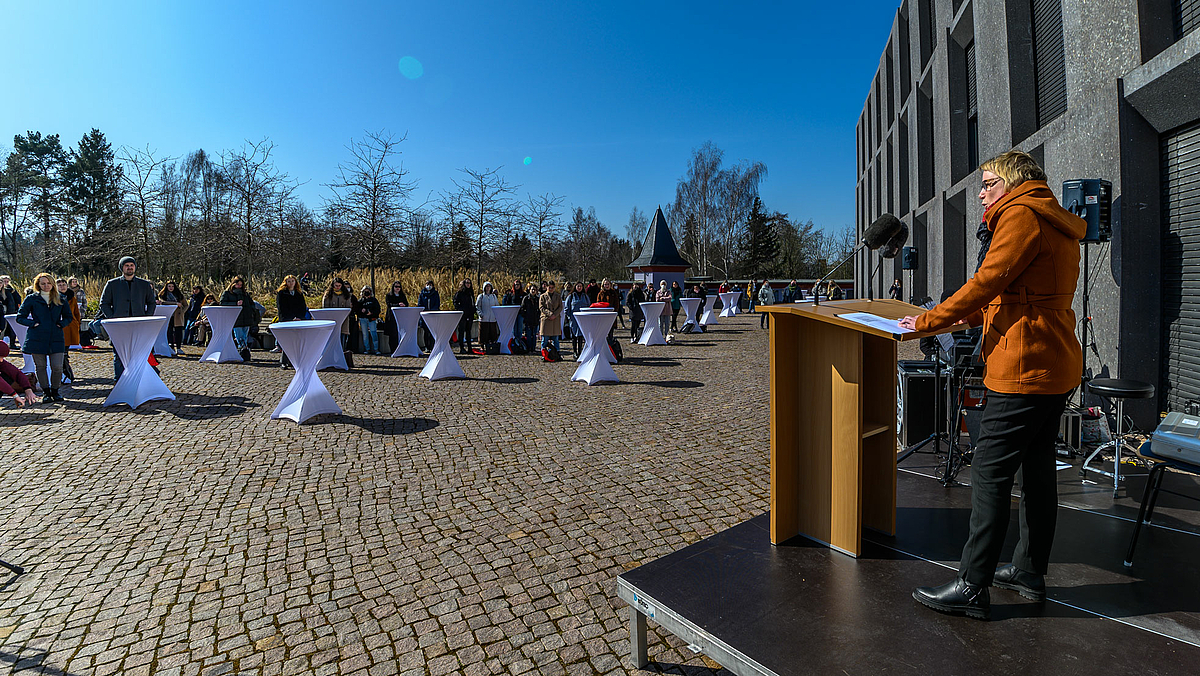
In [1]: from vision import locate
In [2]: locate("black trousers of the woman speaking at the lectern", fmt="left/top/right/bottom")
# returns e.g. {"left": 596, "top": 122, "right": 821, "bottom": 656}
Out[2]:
{"left": 959, "top": 390, "right": 1070, "bottom": 587}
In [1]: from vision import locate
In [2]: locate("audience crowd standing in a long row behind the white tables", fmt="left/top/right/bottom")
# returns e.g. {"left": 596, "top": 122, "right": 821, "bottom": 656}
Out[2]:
{"left": 0, "top": 256, "right": 840, "bottom": 406}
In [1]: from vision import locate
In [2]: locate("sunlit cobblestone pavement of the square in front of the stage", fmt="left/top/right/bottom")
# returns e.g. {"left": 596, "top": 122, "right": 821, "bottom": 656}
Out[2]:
{"left": 0, "top": 316, "right": 769, "bottom": 676}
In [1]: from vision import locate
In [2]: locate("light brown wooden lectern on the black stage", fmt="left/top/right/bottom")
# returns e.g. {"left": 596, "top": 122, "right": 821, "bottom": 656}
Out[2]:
{"left": 758, "top": 300, "right": 966, "bottom": 556}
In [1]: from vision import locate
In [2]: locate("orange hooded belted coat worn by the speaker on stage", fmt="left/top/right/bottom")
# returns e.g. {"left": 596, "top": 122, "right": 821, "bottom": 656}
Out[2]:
{"left": 917, "top": 181, "right": 1087, "bottom": 394}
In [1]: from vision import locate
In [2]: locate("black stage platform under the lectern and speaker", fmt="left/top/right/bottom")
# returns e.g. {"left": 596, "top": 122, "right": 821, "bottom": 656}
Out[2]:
{"left": 617, "top": 455, "right": 1200, "bottom": 676}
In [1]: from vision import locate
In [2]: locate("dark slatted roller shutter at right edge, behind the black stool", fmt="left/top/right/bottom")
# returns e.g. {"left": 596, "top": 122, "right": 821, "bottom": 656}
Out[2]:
{"left": 1160, "top": 125, "right": 1200, "bottom": 411}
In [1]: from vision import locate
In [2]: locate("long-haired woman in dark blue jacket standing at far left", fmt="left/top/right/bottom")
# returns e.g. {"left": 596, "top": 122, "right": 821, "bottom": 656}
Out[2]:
{"left": 17, "top": 273, "right": 74, "bottom": 402}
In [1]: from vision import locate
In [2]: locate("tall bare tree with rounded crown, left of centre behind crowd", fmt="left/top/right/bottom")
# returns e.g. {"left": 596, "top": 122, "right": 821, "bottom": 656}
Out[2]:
{"left": 328, "top": 131, "right": 416, "bottom": 288}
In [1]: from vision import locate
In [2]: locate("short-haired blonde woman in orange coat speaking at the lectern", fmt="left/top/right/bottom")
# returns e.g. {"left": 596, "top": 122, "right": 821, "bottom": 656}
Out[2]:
{"left": 900, "top": 150, "right": 1086, "bottom": 620}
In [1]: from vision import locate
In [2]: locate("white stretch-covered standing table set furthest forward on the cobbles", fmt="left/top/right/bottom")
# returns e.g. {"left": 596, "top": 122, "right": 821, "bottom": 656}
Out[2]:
{"left": 270, "top": 319, "right": 342, "bottom": 423}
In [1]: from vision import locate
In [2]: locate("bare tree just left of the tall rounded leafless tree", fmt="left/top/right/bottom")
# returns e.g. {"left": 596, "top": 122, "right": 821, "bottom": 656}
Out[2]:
{"left": 221, "top": 138, "right": 288, "bottom": 276}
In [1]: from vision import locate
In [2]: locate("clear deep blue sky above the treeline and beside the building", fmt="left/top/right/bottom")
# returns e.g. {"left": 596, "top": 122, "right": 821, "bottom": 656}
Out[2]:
{"left": 0, "top": 0, "right": 899, "bottom": 234}
